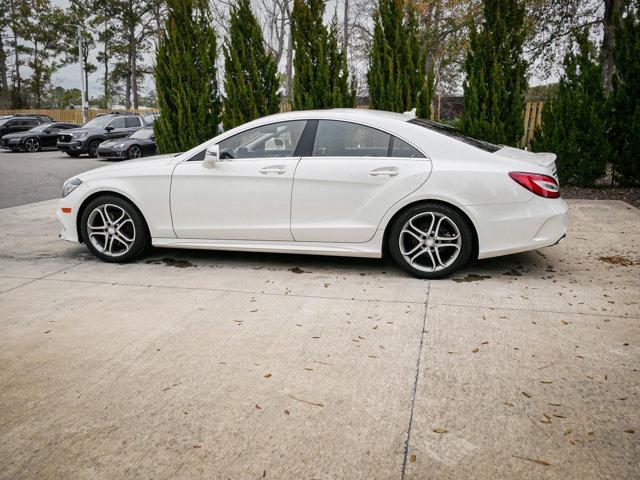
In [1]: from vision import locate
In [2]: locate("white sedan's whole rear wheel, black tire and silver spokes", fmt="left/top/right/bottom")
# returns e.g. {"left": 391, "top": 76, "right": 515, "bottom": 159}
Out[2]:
{"left": 388, "top": 202, "right": 473, "bottom": 279}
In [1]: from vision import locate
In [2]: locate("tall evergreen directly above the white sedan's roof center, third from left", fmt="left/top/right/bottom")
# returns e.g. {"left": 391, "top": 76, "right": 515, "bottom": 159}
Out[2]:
{"left": 291, "top": 0, "right": 355, "bottom": 110}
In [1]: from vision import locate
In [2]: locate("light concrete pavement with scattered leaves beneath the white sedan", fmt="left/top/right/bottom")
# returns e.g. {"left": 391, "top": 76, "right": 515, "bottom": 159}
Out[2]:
{"left": 0, "top": 201, "right": 640, "bottom": 479}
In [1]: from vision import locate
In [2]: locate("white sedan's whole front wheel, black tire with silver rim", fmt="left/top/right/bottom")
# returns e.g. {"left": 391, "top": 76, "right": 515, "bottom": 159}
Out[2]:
{"left": 80, "top": 195, "right": 149, "bottom": 263}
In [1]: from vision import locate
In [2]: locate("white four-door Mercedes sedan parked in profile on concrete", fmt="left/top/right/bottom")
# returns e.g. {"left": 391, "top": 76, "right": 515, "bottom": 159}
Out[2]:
{"left": 57, "top": 109, "right": 567, "bottom": 278}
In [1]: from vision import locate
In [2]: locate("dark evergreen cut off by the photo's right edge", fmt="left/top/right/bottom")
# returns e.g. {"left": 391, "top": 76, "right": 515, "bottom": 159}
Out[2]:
{"left": 608, "top": 0, "right": 640, "bottom": 186}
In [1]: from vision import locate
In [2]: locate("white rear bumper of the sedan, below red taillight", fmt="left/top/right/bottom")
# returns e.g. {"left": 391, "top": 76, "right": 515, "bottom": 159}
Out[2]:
{"left": 467, "top": 197, "right": 568, "bottom": 258}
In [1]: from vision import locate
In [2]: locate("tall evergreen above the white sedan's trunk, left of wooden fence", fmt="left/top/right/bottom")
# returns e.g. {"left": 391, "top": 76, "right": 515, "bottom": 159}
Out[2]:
{"left": 462, "top": 0, "right": 527, "bottom": 146}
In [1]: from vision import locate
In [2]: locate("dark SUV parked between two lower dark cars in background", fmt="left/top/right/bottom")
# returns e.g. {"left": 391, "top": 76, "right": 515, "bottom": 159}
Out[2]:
{"left": 58, "top": 113, "right": 145, "bottom": 157}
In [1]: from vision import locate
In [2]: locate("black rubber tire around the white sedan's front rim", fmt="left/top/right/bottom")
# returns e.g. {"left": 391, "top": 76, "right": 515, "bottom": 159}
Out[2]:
{"left": 80, "top": 195, "right": 151, "bottom": 263}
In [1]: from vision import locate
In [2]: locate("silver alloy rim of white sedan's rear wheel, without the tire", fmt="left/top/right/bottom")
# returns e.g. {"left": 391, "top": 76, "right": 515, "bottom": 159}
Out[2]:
{"left": 398, "top": 212, "right": 462, "bottom": 272}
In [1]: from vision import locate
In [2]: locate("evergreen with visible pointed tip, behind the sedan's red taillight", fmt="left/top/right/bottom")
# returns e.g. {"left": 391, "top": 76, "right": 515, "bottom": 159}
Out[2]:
{"left": 531, "top": 30, "right": 609, "bottom": 186}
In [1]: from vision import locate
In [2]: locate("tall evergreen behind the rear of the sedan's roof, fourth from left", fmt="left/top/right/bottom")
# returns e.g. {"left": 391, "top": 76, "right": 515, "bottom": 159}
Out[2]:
{"left": 367, "top": 0, "right": 433, "bottom": 118}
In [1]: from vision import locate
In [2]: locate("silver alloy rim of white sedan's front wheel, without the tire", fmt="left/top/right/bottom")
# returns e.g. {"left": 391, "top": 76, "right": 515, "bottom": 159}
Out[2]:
{"left": 87, "top": 203, "right": 136, "bottom": 257}
